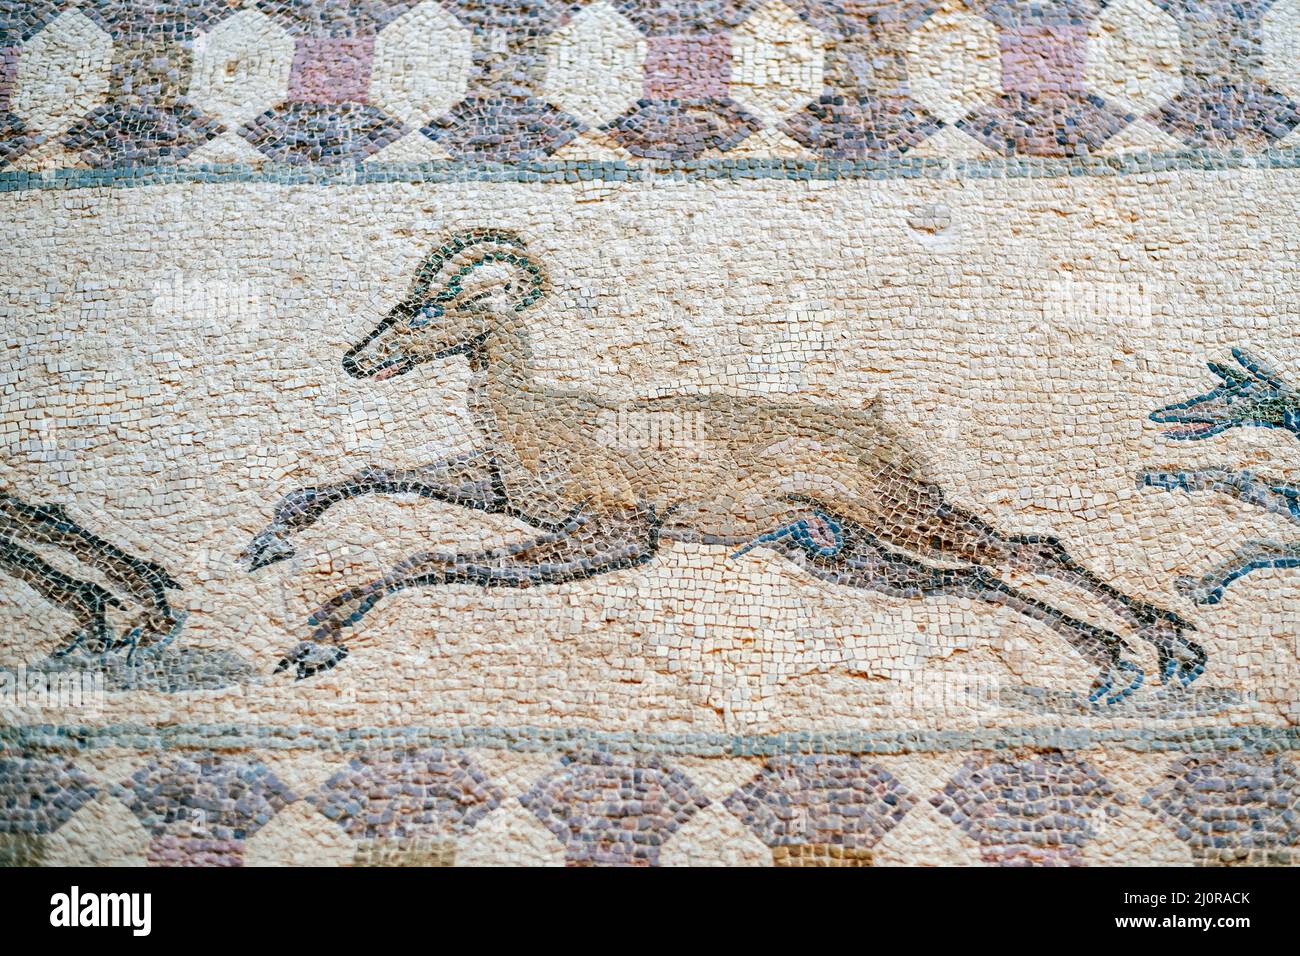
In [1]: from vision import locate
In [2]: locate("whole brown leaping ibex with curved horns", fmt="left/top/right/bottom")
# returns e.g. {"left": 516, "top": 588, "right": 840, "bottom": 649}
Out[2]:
{"left": 241, "top": 229, "right": 1206, "bottom": 702}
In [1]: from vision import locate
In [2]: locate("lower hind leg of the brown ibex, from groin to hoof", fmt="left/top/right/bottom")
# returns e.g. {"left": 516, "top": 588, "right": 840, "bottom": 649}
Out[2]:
{"left": 764, "top": 510, "right": 1143, "bottom": 704}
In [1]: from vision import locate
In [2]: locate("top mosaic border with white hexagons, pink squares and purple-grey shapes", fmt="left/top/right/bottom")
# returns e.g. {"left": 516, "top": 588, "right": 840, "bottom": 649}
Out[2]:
{"left": 0, "top": 0, "right": 1300, "bottom": 170}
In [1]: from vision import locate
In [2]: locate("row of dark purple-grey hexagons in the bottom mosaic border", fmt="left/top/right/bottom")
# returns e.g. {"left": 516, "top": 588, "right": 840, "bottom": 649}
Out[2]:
{"left": 0, "top": 748, "right": 1300, "bottom": 866}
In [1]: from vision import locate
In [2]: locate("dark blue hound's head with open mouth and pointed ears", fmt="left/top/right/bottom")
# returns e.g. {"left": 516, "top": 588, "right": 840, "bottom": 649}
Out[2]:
{"left": 1151, "top": 349, "right": 1300, "bottom": 441}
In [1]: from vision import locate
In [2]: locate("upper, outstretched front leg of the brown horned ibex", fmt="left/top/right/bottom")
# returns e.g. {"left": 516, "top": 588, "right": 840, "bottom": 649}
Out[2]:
{"left": 239, "top": 451, "right": 508, "bottom": 571}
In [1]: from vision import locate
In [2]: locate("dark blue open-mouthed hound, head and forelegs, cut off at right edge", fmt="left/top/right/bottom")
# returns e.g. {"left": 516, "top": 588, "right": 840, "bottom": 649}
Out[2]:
{"left": 1138, "top": 349, "right": 1300, "bottom": 605}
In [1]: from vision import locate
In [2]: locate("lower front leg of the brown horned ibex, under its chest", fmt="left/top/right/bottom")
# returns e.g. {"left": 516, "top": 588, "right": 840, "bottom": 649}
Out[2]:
{"left": 276, "top": 511, "right": 659, "bottom": 679}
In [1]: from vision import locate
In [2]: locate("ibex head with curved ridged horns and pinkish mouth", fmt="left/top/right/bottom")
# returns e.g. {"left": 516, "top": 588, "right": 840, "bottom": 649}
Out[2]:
{"left": 343, "top": 229, "right": 547, "bottom": 380}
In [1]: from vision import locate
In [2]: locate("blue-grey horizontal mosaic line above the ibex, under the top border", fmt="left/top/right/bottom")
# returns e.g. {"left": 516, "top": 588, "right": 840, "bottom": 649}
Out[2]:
{"left": 0, "top": 147, "right": 1300, "bottom": 193}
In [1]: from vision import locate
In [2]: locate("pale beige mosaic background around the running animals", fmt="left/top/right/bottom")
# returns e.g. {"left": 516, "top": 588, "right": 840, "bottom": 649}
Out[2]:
{"left": 0, "top": 170, "right": 1300, "bottom": 734}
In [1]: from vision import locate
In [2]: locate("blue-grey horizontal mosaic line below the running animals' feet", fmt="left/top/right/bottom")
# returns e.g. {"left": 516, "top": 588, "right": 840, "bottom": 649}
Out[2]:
{"left": 0, "top": 724, "right": 1300, "bottom": 757}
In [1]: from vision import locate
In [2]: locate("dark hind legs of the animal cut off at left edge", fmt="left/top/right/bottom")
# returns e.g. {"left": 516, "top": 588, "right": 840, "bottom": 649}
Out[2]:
{"left": 0, "top": 493, "right": 186, "bottom": 661}
